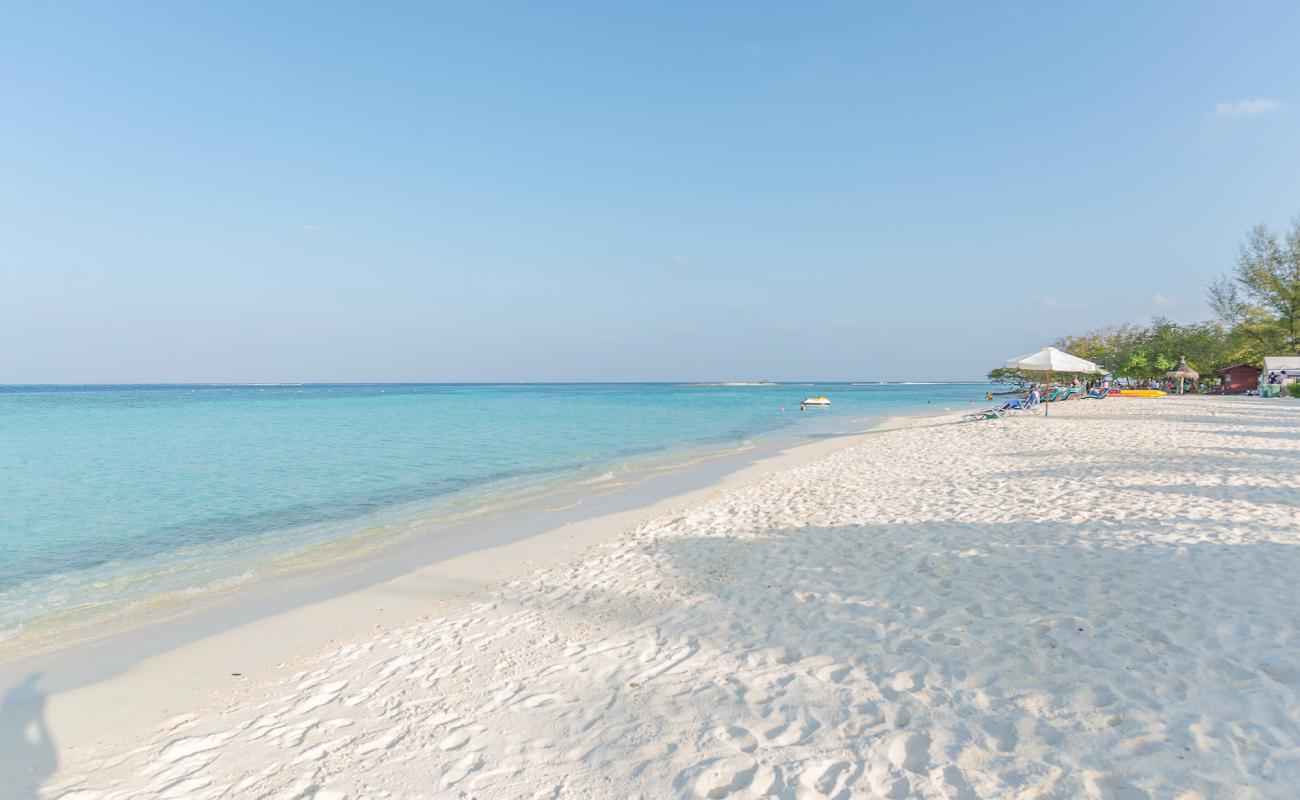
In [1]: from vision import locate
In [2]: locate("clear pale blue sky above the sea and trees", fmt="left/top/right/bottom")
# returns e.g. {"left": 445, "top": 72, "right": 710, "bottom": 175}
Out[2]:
{"left": 0, "top": 3, "right": 1300, "bottom": 382}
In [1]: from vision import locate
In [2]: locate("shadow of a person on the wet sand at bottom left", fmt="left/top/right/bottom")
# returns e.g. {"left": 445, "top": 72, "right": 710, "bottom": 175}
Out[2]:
{"left": 0, "top": 673, "right": 59, "bottom": 800}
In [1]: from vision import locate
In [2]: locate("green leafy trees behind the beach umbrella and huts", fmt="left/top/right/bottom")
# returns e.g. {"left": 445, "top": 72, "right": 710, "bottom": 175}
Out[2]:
{"left": 988, "top": 217, "right": 1300, "bottom": 384}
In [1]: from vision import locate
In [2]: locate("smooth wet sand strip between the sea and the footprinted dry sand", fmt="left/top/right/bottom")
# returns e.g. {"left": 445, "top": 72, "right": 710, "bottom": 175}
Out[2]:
{"left": 0, "top": 410, "right": 959, "bottom": 757}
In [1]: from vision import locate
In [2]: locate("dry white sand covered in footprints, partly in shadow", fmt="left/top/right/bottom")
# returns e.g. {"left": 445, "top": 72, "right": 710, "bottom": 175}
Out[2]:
{"left": 22, "top": 398, "right": 1300, "bottom": 800}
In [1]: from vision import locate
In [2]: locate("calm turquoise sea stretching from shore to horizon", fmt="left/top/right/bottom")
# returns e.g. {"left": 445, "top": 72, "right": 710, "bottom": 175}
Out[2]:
{"left": 0, "top": 384, "right": 988, "bottom": 637}
